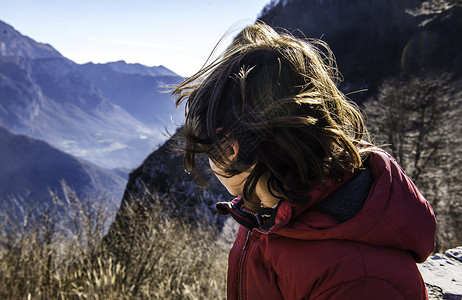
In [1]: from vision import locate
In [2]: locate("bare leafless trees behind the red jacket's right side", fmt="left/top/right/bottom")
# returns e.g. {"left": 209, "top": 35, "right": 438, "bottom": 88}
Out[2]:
{"left": 364, "top": 73, "right": 462, "bottom": 251}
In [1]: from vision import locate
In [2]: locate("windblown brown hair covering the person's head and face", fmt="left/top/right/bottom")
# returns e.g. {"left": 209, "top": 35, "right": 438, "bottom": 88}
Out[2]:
{"left": 173, "top": 22, "right": 368, "bottom": 206}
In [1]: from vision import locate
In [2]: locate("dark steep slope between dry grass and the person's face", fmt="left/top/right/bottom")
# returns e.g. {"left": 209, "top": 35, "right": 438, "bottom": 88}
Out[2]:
{"left": 104, "top": 129, "right": 231, "bottom": 257}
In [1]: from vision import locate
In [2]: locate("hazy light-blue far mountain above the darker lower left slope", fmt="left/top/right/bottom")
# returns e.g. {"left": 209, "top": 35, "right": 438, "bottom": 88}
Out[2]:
{"left": 0, "top": 21, "right": 182, "bottom": 168}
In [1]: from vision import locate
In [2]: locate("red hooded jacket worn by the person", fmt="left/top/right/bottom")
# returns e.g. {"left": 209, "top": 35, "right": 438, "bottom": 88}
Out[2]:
{"left": 217, "top": 152, "right": 436, "bottom": 300}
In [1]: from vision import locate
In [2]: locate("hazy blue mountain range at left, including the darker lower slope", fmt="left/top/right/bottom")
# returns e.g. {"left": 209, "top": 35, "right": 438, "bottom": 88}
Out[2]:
{"left": 0, "top": 21, "right": 182, "bottom": 205}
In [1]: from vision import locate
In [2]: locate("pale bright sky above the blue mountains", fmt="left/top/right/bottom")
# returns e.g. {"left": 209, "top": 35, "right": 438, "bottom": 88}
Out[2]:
{"left": 0, "top": 0, "right": 270, "bottom": 76}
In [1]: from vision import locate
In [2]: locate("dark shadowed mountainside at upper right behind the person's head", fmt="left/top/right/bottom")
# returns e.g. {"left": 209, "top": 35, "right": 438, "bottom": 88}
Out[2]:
{"left": 259, "top": 0, "right": 462, "bottom": 102}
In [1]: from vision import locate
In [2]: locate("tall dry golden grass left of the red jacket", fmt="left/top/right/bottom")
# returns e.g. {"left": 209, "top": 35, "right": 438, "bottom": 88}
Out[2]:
{"left": 0, "top": 184, "right": 229, "bottom": 300}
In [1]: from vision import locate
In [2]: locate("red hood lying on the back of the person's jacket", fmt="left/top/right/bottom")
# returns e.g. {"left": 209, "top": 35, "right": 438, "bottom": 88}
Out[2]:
{"left": 217, "top": 151, "right": 436, "bottom": 262}
